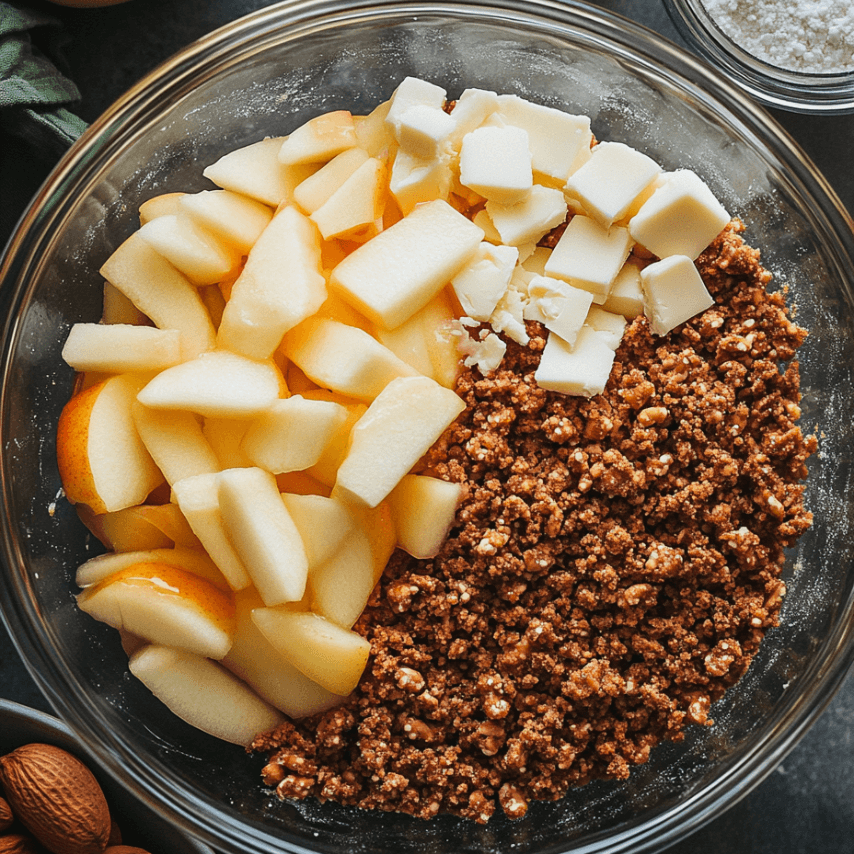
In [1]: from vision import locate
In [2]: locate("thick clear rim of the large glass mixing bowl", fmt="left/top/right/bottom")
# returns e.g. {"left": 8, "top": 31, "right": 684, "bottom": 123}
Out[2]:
{"left": 0, "top": 0, "right": 854, "bottom": 854}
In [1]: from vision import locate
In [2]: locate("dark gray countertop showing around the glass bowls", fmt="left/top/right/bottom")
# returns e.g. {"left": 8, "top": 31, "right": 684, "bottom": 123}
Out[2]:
{"left": 0, "top": 0, "right": 854, "bottom": 854}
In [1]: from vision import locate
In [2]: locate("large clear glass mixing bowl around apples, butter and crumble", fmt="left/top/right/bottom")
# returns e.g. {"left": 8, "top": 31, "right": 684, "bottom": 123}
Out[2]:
{"left": 0, "top": 0, "right": 854, "bottom": 854}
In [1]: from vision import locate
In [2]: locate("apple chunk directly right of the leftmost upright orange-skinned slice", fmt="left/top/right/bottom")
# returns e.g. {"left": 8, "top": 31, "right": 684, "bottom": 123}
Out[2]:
{"left": 132, "top": 401, "right": 221, "bottom": 484}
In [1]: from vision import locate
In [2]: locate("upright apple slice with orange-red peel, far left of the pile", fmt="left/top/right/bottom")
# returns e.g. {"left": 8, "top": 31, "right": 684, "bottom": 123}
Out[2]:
{"left": 56, "top": 374, "right": 163, "bottom": 513}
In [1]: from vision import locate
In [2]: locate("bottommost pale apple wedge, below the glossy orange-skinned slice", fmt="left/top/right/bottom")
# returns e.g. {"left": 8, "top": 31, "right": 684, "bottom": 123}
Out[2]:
{"left": 128, "top": 644, "right": 283, "bottom": 747}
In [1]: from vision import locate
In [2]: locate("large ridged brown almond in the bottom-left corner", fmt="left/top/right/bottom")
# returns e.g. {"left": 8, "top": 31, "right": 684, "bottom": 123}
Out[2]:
{"left": 0, "top": 744, "right": 111, "bottom": 854}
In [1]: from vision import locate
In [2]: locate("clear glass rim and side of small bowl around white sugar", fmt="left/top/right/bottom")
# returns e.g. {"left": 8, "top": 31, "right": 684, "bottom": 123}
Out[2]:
{"left": 664, "top": 0, "right": 854, "bottom": 115}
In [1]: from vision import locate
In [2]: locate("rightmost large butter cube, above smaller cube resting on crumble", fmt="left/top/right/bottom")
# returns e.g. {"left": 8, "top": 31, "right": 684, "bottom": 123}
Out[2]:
{"left": 629, "top": 169, "right": 730, "bottom": 260}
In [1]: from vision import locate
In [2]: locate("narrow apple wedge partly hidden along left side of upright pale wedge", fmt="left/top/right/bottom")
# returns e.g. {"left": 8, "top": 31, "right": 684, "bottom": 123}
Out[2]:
{"left": 172, "top": 474, "right": 250, "bottom": 590}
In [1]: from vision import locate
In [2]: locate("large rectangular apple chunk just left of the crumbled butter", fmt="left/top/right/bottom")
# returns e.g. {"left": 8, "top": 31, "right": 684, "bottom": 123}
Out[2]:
{"left": 329, "top": 199, "right": 483, "bottom": 329}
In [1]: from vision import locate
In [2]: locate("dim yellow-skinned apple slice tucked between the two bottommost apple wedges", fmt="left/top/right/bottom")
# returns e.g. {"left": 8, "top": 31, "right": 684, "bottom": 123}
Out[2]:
{"left": 222, "top": 587, "right": 345, "bottom": 718}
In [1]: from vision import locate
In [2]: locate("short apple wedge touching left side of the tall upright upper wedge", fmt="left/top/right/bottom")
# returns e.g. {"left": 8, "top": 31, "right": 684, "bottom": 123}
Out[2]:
{"left": 137, "top": 216, "right": 240, "bottom": 286}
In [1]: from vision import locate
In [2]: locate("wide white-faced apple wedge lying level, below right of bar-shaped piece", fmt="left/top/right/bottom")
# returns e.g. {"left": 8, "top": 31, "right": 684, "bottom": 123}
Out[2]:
{"left": 137, "top": 350, "right": 283, "bottom": 418}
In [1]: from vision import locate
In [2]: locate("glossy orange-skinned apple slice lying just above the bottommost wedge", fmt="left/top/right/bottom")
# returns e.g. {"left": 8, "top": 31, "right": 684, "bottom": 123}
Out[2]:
{"left": 77, "top": 563, "right": 234, "bottom": 658}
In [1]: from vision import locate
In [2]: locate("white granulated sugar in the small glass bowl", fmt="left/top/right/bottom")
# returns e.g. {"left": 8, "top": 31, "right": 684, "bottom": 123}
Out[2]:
{"left": 704, "top": 0, "right": 854, "bottom": 74}
